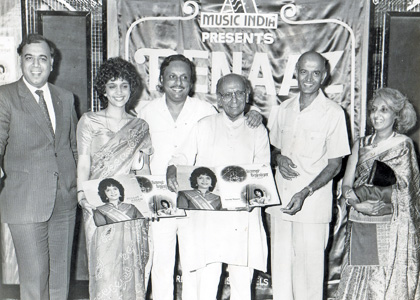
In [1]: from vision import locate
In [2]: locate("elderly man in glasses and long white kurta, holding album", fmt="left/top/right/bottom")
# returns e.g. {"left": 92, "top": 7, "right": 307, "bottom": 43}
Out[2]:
{"left": 168, "top": 74, "right": 270, "bottom": 300}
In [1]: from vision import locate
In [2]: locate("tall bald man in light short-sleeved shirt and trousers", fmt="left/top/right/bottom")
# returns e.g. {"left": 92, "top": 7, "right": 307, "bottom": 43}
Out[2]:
{"left": 266, "top": 51, "right": 350, "bottom": 300}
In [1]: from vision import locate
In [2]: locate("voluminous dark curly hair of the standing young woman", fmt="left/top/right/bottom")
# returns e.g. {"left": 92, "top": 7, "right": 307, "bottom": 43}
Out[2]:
{"left": 95, "top": 57, "right": 143, "bottom": 114}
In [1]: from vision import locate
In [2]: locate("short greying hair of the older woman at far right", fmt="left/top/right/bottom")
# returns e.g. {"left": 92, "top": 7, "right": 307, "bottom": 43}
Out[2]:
{"left": 368, "top": 88, "right": 417, "bottom": 133}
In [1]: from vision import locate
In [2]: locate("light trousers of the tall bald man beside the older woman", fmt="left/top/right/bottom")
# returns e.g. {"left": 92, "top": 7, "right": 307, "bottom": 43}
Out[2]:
{"left": 271, "top": 215, "right": 329, "bottom": 300}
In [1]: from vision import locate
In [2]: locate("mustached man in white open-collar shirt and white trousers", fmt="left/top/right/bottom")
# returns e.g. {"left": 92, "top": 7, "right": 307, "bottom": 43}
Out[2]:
{"left": 139, "top": 54, "right": 261, "bottom": 300}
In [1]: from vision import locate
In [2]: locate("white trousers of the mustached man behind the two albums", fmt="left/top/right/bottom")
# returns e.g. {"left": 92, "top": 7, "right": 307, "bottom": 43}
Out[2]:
{"left": 152, "top": 218, "right": 197, "bottom": 300}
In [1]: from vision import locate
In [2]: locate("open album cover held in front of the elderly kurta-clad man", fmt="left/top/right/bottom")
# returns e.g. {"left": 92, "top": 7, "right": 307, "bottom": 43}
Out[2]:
{"left": 177, "top": 164, "right": 280, "bottom": 211}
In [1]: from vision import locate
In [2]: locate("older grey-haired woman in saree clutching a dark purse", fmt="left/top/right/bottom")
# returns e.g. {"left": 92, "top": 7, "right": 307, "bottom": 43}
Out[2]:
{"left": 336, "top": 88, "right": 420, "bottom": 300}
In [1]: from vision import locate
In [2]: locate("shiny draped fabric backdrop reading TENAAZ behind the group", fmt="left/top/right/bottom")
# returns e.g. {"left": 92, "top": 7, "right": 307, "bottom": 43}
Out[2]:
{"left": 107, "top": 0, "right": 369, "bottom": 299}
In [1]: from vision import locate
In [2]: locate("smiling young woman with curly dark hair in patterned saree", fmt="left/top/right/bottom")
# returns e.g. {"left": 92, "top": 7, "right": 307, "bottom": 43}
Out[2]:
{"left": 77, "top": 58, "right": 152, "bottom": 300}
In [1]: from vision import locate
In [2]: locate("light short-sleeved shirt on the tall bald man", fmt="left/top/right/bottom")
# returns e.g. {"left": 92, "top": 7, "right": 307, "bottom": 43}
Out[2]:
{"left": 266, "top": 91, "right": 350, "bottom": 223}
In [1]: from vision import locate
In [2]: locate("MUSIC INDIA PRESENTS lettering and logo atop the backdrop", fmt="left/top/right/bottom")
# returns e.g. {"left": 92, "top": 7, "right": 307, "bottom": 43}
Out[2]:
{"left": 200, "top": 0, "right": 278, "bottom": 44}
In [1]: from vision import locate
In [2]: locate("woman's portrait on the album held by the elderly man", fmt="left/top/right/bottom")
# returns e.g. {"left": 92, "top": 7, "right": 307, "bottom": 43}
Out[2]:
{"left": 177, "top": 167, "right": 222, "bottom": 210}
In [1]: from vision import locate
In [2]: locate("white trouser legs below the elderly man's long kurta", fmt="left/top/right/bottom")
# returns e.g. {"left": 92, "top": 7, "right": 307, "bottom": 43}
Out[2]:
{"left": 196, "top": 263, "right": 254, "bottom": 300}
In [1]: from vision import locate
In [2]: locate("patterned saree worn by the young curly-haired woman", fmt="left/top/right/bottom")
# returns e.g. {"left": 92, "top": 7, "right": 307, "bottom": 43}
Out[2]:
{"left": 81, "top": 118, "right": 152, "bottom": 300}
